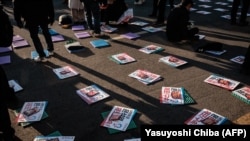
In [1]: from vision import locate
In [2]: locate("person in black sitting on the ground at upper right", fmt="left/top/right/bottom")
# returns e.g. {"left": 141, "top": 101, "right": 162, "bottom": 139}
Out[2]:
{"left": 166, "top": 0, "right": 199, "bottom": 42}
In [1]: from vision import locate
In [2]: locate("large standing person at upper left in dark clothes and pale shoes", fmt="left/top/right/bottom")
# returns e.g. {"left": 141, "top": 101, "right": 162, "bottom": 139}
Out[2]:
{"left": 14, "top": 0, "right": 55, "bottom": 62}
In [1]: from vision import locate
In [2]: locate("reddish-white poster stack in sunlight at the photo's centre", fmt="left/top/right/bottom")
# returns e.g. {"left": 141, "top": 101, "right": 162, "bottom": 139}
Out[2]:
{"left": 128, "top": 69, "right": 162, "bottom": 85}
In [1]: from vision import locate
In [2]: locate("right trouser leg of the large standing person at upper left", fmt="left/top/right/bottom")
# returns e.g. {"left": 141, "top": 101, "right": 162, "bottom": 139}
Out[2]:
{"left": 40, "top": 23, "right": 54, "bottom": 52}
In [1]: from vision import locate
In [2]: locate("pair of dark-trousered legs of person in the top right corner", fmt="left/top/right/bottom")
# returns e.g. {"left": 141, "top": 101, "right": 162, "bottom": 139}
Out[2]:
{"left": 231, "top": 0, "right": 250, "bottom": 26}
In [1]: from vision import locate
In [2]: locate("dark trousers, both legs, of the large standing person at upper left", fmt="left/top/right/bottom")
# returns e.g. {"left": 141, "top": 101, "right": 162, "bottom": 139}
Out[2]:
{"left": 27, "top": 23, "right": 54, "bottom": 57}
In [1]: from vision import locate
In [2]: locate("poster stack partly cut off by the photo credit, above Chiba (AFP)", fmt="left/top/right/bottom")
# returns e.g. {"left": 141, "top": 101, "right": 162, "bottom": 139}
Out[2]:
{"left": 184, "top": 108, "right": 228, "bottom": 125}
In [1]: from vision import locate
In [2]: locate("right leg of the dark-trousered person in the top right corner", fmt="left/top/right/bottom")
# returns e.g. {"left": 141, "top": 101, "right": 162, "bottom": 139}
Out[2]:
{"left": 239, "top": 0, "right": 250, "bottom": 26}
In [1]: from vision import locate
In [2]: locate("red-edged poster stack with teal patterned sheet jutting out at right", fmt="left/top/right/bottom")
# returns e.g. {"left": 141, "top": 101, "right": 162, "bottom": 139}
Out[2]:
{"left": 160, "top": 87, "right": 195, "bottom": 105}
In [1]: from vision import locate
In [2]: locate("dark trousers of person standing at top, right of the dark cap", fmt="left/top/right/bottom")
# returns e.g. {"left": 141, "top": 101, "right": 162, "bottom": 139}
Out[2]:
{"left": 84, "top": 0, "right": 101, "bottom": 34}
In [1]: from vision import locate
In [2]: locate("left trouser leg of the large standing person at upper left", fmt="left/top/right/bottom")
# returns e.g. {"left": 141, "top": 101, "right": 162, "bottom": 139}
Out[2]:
{"left": 28, "top": 24, "right": 46, "bottom": 58}
